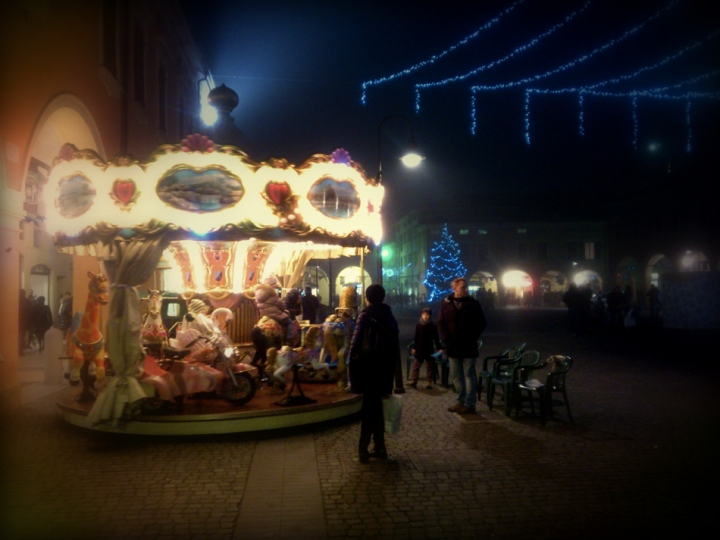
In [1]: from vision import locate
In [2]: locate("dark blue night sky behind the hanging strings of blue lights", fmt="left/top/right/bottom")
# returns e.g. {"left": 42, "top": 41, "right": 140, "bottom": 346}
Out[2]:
{"left": 183, "top": 0, "right": 720, "bottom": 224}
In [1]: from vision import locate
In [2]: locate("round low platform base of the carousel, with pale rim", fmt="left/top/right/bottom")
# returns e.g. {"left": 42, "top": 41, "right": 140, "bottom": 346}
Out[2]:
{"left": 55, "top": 383, "right": 362, "bottom": 435}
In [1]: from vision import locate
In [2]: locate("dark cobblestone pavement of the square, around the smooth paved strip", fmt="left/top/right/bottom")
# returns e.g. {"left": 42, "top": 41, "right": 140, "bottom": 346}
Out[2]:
{"left": 0, "top": 313, "right": 720, "bottom": 539}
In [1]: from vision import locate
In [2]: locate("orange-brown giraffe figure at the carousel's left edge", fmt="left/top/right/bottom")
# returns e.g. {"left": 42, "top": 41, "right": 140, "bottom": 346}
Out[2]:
{"left": 68, "top": 272, "right": 108, "bottom": 401}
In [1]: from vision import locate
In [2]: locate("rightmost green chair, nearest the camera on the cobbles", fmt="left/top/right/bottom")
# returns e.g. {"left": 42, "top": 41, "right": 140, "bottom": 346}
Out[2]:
{"left": 516, "top": 355, "right": 573, "bottom": 426}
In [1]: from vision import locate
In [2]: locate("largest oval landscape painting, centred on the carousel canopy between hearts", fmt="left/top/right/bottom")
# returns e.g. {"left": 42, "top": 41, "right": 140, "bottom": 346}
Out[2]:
{"left": 156, "top": 166, "right": 245, "bottom": 212}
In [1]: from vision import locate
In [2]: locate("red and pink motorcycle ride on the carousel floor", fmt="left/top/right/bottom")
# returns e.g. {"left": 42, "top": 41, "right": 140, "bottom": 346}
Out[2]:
{"left": 140, "top": 331, "right": 257, "bottom": 411}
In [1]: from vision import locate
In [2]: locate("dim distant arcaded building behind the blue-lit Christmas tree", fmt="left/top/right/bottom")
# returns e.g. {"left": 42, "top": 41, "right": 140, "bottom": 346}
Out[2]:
{"left": 386, "top": 206, "right": 608, "bottom": 305}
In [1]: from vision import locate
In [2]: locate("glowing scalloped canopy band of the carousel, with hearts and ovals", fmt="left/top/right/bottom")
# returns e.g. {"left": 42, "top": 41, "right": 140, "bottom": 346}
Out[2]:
{"left": 47, "top": 139, "right": 384, "bottom": 249}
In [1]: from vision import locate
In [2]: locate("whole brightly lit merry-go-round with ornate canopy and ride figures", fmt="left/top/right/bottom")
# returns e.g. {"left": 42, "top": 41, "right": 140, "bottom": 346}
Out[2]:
{"left": 47, "top": 135, "right": 383, "bottom": 435}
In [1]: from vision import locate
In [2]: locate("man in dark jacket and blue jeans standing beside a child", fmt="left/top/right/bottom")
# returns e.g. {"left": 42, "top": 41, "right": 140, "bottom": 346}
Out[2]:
{"left": 438, "top": 278, "right": 487, "bottom": 414}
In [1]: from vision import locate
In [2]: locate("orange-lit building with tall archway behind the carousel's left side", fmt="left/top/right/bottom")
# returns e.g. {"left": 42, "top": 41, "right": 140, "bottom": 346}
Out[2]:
{"left": 0, "top": 0, "right": 208, "bottom": 407}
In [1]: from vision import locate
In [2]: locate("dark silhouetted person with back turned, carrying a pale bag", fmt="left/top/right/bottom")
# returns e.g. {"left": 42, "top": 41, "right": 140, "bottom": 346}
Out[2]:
{"left": 350, "top": 284, "right": 400, "bottom": 463}
